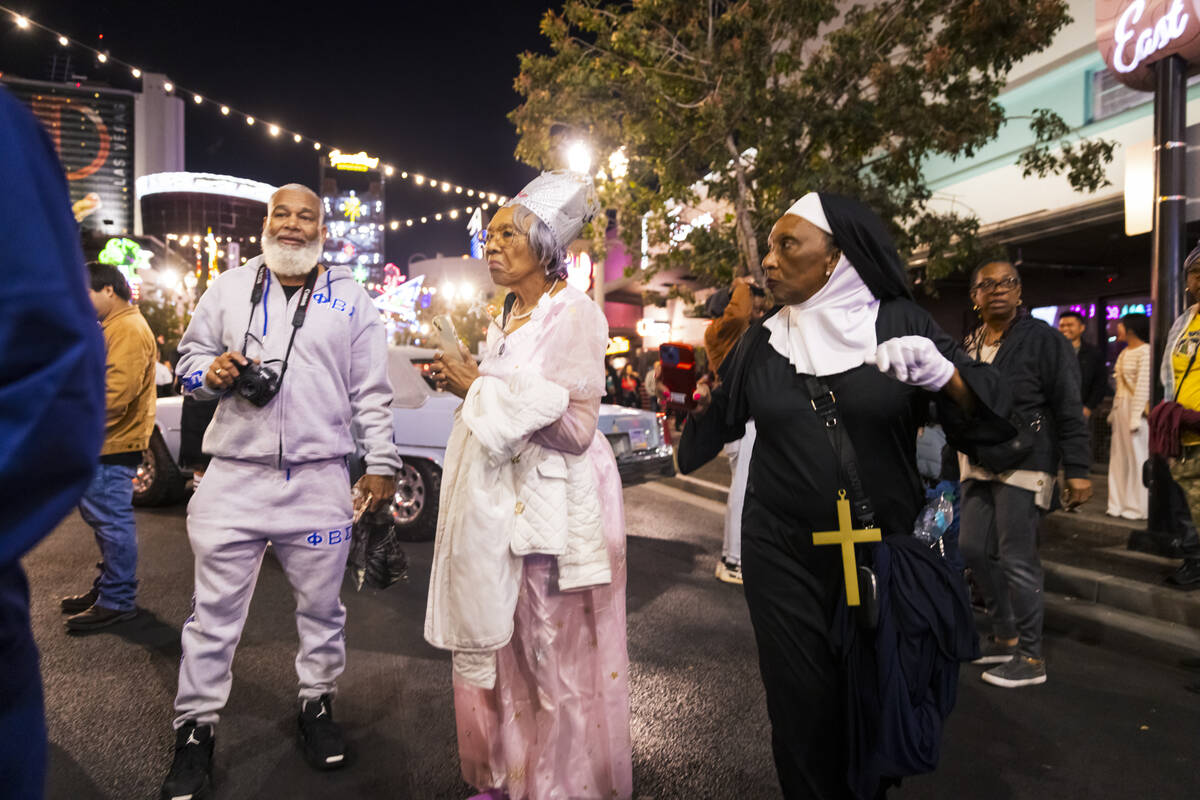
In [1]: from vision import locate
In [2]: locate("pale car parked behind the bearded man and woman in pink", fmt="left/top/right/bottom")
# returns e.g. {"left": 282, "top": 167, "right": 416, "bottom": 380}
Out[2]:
{"left": 133, "top": 347, "right": 674, "bottom": 541}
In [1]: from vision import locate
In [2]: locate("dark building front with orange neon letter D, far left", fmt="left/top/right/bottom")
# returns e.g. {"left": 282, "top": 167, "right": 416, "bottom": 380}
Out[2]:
{"left": 5, "top": 78, "right": 133, "bottom": 235}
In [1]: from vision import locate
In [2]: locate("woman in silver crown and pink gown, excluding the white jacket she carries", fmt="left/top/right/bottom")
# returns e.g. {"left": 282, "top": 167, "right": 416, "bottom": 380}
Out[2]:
{"left": 434, "top": 175, "right": 632, "bottom": 800}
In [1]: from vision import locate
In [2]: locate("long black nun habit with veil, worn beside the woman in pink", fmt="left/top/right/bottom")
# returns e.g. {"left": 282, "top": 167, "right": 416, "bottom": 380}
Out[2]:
{"left": 678, "top": 193, "right": 1014, "bottom": 800}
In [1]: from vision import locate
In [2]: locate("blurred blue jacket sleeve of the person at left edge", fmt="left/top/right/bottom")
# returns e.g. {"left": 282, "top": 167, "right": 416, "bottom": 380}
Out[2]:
{"left": 0, "top": 88, "right": 104, "bottom": 569}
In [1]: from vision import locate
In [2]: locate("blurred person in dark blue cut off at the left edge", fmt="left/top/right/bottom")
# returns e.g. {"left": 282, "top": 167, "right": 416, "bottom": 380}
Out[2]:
{"left": 0, "top": 86, "right": 104, "bottom": 800}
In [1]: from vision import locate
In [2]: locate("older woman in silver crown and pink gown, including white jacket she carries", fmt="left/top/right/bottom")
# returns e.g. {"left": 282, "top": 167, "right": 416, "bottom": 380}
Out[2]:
{"left": 425, "top": 173, "right": 632, "bottom": 800}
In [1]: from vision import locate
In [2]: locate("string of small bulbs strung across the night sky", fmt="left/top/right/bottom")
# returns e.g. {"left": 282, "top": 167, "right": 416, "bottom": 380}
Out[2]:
{"left": 0, "top": 5, "right": 508, "bottom": 206}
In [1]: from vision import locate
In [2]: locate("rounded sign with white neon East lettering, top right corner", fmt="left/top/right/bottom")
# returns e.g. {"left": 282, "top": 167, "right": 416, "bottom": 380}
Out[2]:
{"left": 1096, "top": 0, "right": 1200, "bottom": 91}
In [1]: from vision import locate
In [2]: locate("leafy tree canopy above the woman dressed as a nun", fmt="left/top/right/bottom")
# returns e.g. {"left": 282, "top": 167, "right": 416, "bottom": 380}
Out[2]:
{"left": 510, "top": 0, "right": 1114, "bottom": 283}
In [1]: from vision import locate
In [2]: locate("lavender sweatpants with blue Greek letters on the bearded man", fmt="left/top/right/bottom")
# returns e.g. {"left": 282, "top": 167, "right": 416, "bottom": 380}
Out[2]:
{"left": 175, "top": 458, "right": 353, "bottom": 729}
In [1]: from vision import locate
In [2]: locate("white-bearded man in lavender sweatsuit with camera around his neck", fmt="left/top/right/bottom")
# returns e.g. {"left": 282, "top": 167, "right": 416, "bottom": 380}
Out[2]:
{"left": 161, "top": 184, "right": 401, "bottom": 800}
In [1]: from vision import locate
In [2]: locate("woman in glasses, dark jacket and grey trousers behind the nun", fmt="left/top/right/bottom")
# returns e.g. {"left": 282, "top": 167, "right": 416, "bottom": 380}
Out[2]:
{"left": 960, "top": 261, "right": 1092, "bottom": 688}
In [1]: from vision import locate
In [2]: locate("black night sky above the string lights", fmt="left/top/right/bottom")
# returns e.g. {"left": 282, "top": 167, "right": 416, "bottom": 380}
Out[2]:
{"left": 0, "top": 0, "right": 558, "bottom": 265}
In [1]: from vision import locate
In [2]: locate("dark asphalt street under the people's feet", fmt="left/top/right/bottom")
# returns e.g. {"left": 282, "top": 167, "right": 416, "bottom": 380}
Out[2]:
{"left": 18, "top": 483, "right": 1200, "bottom": 800}
